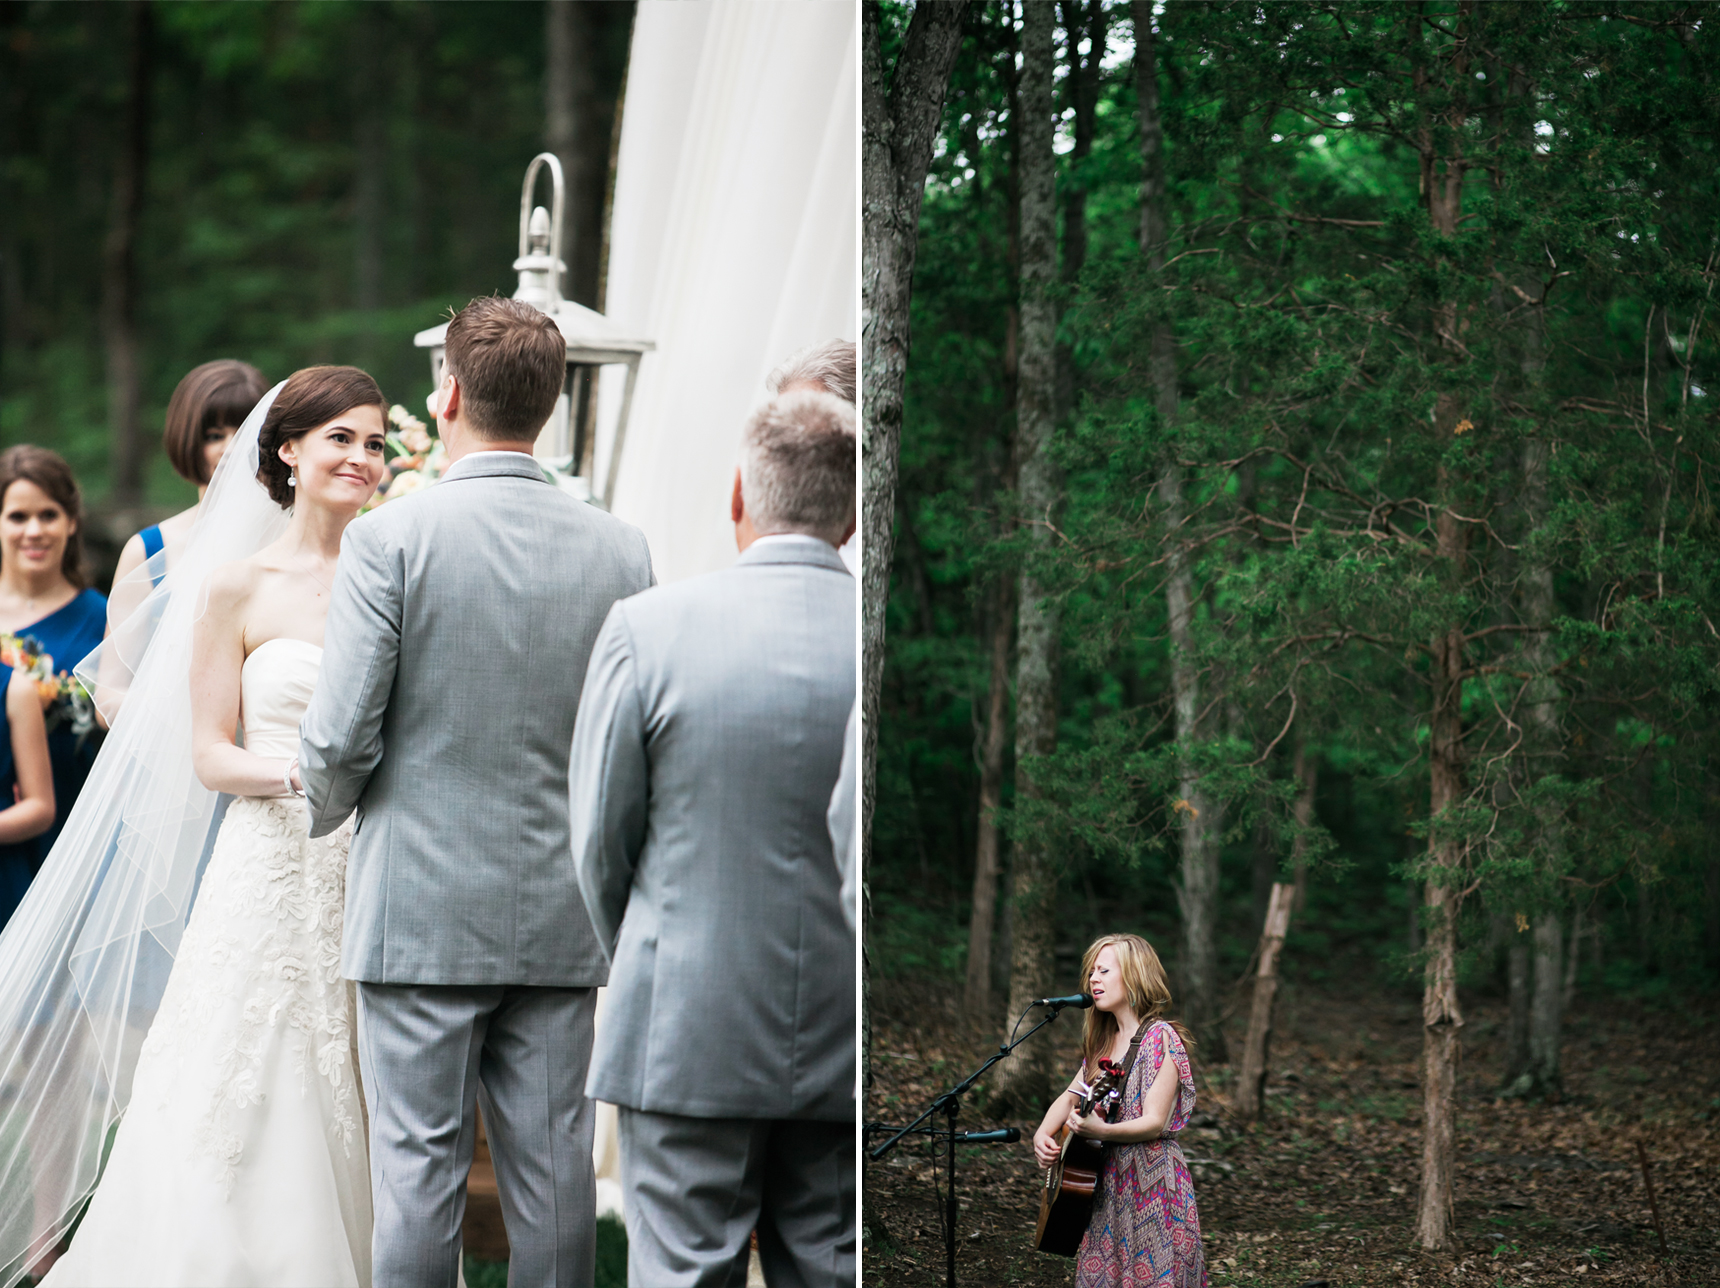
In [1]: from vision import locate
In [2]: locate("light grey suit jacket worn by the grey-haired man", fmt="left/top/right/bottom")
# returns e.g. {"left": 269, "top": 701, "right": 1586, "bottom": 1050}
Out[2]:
{"left": 569, "top": 537, "right": 857, "bottom": 1121}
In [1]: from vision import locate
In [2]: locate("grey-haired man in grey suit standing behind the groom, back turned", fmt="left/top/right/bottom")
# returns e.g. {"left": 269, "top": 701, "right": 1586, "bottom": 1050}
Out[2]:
{"left": 569, "top": 392, "right": 857, "bottom": 1288}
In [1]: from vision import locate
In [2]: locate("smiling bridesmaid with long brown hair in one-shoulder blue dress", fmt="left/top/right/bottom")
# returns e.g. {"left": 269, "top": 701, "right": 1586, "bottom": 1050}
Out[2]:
{"left": 0, "top": 444, "right": 107, "bottom": 867}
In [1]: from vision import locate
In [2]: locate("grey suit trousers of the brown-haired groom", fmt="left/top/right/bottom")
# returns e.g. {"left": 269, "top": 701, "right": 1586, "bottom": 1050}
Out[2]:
{"left": 358, "top": 984, "right": 598, "bottom": 1288}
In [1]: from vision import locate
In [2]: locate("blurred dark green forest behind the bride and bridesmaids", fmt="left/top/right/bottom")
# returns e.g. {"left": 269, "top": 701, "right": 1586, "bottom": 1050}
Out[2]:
{"left": 0, "top": 0, "right": 633, "bottom": 581}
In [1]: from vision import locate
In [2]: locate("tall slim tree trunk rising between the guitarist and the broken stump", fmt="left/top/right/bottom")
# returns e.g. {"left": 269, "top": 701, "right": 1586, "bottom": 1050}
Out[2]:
{"left": 1130, "top": 0, "right": 1226, "bottom": 1063}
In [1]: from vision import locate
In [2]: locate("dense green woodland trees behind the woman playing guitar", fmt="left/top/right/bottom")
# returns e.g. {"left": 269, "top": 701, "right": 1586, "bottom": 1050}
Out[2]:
{"left": 869, "top": 0, "right": 1720, "bottom": 1203}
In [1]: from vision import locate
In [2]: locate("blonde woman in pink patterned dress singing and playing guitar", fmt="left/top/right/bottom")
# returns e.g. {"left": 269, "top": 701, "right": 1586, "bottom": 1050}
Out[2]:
{"left": 1034, "top": 934, "right": 1206, "bottom": 1288}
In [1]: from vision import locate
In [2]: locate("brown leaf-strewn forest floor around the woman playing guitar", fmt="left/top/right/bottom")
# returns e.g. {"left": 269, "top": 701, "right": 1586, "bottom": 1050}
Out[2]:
{"left": 862, "top": 980, "right": 1720, "bottom": 1288}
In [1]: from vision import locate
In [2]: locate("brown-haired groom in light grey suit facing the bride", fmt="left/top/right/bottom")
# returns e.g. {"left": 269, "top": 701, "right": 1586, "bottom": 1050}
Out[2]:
{"left": 301, "top": 299, "right": 652, "bottom": 1288}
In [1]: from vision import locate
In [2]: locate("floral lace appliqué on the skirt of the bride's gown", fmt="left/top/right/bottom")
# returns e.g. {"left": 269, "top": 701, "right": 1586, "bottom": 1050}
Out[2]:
{"left": 139, "top": 798, "right": 358, "bottom": 1187}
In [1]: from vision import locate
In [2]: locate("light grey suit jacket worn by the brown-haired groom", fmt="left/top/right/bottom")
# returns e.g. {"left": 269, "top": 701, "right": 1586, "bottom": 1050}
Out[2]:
{"left": 299, "top": 452, "right": 652, "bottom": 987}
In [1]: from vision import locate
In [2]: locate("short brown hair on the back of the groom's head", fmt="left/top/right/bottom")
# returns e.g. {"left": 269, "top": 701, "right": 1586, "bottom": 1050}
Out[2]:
{"left": 442, "top": 296, "right": 568, "bottom": 442}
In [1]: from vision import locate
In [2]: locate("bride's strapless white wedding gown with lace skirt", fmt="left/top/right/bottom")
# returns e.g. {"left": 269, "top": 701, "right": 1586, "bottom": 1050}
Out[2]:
{"left": 43, "top": 640, "right": 372, "bottom": 1288}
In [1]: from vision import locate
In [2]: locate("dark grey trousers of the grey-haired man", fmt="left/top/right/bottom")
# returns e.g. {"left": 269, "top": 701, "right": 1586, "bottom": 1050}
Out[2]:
{"left": 617, "top": 1106, "right": 855, "bottom": 1288}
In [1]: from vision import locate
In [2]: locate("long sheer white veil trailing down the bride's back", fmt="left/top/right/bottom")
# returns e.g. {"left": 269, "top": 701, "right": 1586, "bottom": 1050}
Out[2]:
{"left": 0, "top": 385, "right": 287, "bottom": 1288}
